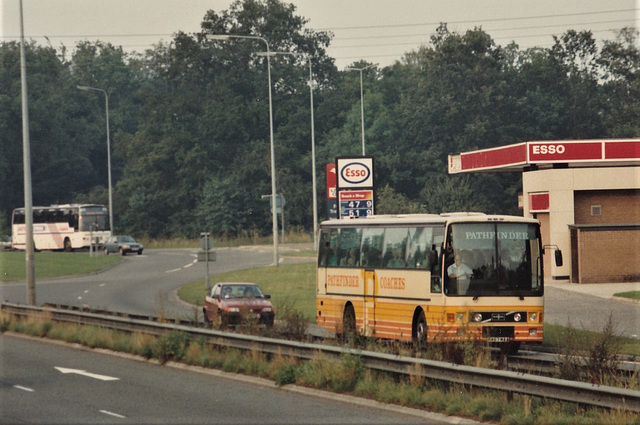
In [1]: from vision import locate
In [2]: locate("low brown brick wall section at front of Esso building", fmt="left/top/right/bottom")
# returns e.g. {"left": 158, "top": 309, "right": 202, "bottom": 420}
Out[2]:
{"left": 574, "top": 227, "right": 640, "bottom": 283}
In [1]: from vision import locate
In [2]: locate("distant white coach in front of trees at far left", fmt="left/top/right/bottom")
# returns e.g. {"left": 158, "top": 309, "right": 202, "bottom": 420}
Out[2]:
{"left": 11, "top": 204, "right": 111, "bottom": 251}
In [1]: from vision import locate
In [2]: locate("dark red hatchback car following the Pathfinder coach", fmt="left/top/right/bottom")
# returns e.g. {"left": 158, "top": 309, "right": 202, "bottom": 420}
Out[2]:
{"left": 203, "top": 282, "right": 275, "bottom": 328}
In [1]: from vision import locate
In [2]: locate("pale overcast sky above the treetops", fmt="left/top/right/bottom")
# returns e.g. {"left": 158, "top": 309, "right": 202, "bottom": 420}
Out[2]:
{"left": 0, "top": 0, "right": 640, "bottom": 69}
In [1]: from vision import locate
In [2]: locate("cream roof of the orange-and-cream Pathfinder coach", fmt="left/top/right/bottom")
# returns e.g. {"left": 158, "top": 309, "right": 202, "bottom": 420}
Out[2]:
{"left": 320, "top": 212, "right": 539, "bottom": 227}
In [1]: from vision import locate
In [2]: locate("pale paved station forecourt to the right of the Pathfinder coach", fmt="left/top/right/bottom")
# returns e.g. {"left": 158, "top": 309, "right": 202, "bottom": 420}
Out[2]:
{"left": 544, "top": 279, "right": 640, "bottom": 340}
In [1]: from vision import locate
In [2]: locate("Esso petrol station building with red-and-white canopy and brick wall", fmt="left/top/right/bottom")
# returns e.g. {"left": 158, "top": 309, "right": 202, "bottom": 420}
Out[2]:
{"left": 449, "top": 139, "right": 640, "bottom": 283}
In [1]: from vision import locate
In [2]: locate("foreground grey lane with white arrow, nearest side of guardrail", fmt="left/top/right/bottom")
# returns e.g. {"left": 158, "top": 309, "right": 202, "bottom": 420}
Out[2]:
{"left": 0, "top": 335, "right": 455, "bottom": 424}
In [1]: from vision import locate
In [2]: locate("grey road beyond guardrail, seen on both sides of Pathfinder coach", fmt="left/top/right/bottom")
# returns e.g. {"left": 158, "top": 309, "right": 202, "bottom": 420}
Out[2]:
{"left": 0, "top": 244, "right": 640, "bottom": 338}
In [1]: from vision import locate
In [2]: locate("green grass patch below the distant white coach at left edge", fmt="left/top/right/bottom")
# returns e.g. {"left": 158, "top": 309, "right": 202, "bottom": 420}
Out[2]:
{"left": 0, "top": 251, "right": 122, "bottom": 282}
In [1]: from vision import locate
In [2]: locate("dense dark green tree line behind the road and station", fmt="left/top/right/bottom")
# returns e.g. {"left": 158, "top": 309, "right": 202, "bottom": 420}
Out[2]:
{"left": 0, "top": 0, "right": 640, "bottom": 237}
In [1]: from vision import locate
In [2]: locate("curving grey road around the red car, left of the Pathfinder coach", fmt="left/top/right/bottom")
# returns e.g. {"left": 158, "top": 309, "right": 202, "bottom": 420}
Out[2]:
{"left": 0, "top": 247, "right": 280, "bottom": 319}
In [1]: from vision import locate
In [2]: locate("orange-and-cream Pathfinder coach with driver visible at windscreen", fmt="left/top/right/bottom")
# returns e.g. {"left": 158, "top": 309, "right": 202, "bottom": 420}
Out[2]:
{"left": 316, "top": 213, "right": 544, "bottom": 352}
